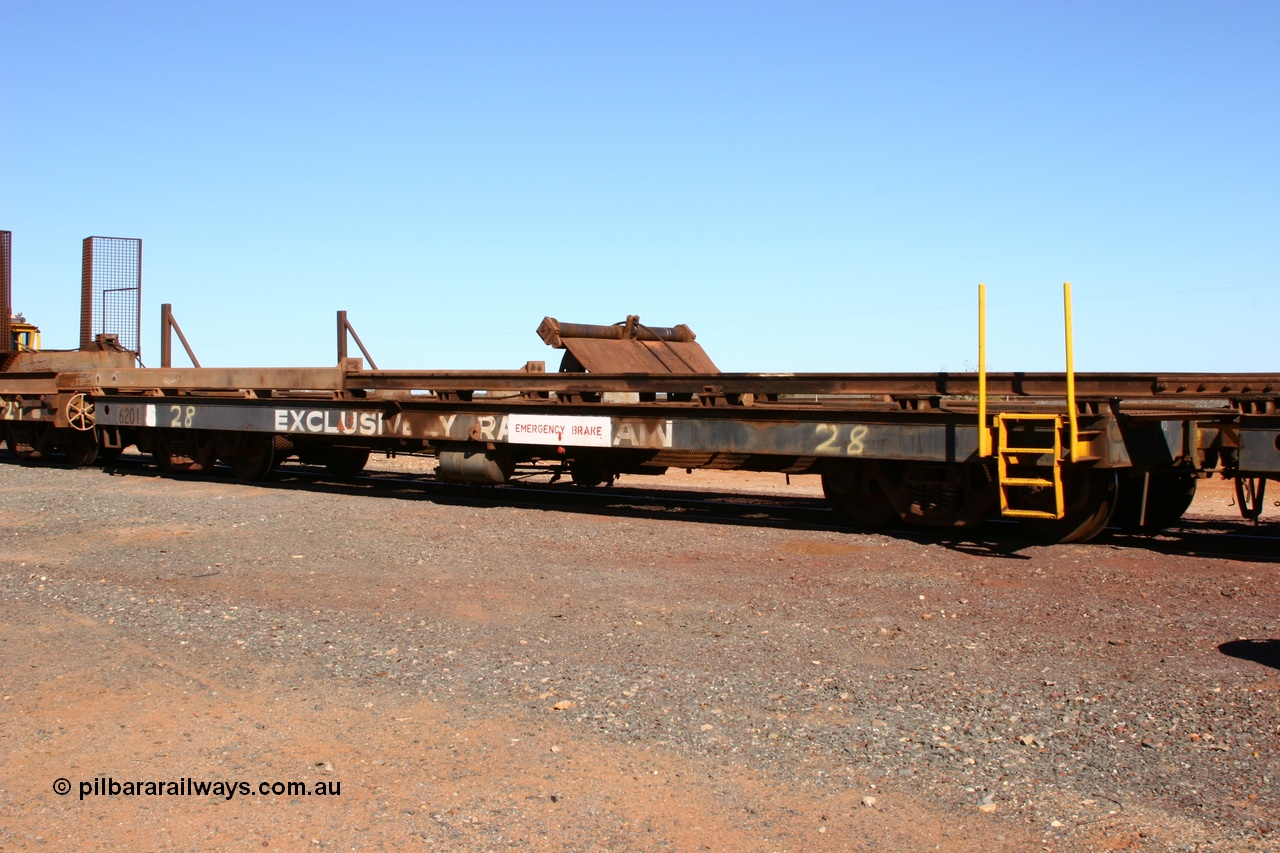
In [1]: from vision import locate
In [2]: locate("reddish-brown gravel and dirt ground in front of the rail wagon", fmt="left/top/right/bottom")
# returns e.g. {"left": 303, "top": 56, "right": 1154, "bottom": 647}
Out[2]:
{"left": 0, "top": 460, "right": 1280, "bottom": 850}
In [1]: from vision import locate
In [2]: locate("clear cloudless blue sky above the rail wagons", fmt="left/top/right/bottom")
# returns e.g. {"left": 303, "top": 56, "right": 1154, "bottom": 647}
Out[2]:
{"left": 0, "top": 0, "right": 1280, "bottom": 371}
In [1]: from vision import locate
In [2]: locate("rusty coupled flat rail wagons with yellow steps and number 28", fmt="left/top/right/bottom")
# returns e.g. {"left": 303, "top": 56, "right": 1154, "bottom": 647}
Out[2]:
{"left": 0, "top": 232, "right": 1280, "bottom": 542}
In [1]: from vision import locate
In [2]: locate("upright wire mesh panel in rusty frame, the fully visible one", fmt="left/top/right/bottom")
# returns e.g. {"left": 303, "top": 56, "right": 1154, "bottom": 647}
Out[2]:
{"left": 81, "top": 237, "right": 142, "bottom": 352}
